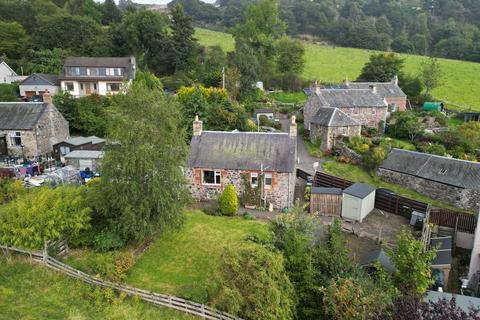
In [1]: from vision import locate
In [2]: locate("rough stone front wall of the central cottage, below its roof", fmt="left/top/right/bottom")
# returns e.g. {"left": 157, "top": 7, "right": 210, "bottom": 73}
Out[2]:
{"left": 185, "top": 168, "right": 295, "bottom": 209}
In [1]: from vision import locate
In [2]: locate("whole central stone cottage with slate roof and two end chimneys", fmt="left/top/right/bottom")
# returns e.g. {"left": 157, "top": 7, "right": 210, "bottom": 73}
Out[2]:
{"left": 185, "top": 117, "right": 297, "bottom": 209}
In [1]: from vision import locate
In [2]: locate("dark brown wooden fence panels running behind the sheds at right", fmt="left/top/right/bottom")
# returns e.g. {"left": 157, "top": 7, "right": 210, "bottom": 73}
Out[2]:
{"left": 313, "top": 171, "right": 477, "bottom": 234}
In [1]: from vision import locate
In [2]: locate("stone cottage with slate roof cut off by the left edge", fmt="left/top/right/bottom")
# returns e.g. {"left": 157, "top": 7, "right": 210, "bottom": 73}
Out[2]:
{"left": 0, "top": 92, "right": 70, "bottom": 157}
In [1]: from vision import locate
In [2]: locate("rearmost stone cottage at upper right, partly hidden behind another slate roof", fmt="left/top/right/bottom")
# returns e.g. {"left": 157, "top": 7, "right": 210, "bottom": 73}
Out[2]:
{"left": 343, "top": 76, "right": 407, "bottom": 112}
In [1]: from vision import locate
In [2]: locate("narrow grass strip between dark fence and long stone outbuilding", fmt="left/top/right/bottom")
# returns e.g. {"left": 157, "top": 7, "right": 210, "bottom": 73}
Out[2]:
{"left": 322, "top": 160, "right": 459, "bottom": 211}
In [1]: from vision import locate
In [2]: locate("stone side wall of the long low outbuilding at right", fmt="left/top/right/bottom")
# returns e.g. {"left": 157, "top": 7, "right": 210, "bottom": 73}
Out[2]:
{"left": 377, "top": 168, "right": 480, "bottom": 213}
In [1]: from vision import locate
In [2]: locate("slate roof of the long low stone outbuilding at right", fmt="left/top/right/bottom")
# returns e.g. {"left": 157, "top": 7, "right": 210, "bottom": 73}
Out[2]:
{"left": 379, "top": 149, "right": 480, "bottom": 190}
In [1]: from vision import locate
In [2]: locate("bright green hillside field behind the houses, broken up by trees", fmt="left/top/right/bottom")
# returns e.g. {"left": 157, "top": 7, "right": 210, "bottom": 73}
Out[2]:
{"left": 196, "top": 29, "right": 480, "bottom": 110}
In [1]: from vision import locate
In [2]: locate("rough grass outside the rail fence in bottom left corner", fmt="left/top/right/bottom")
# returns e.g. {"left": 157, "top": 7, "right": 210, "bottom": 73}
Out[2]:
{"left": 0, "top": 258, "right": 196, "bottom": 320}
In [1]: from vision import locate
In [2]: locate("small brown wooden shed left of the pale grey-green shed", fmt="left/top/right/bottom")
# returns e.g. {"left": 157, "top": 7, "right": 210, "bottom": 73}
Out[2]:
{"left": 310, "top": 187, "right": 342, "bottom": 217}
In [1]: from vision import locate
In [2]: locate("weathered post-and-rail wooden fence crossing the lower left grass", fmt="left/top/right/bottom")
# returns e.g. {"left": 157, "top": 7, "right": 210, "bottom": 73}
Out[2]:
{"left": 0, "top": 245, "right": 239, "bottom": 320}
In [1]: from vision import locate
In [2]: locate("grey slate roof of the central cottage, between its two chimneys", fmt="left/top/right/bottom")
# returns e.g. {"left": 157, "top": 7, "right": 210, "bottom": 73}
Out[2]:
{"left": 188, "top": 131, "right": 297, "bottom": 172}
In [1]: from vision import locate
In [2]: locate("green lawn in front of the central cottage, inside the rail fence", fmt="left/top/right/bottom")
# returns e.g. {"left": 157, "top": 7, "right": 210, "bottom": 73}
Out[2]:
{"left": 127, "top": 211, "right": 268, "bottom": 301}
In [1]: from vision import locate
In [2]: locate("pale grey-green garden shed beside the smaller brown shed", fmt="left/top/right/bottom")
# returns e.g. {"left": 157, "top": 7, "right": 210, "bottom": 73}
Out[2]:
{"left": 342, "top": 183, "right": 375, "bottom": 222}
